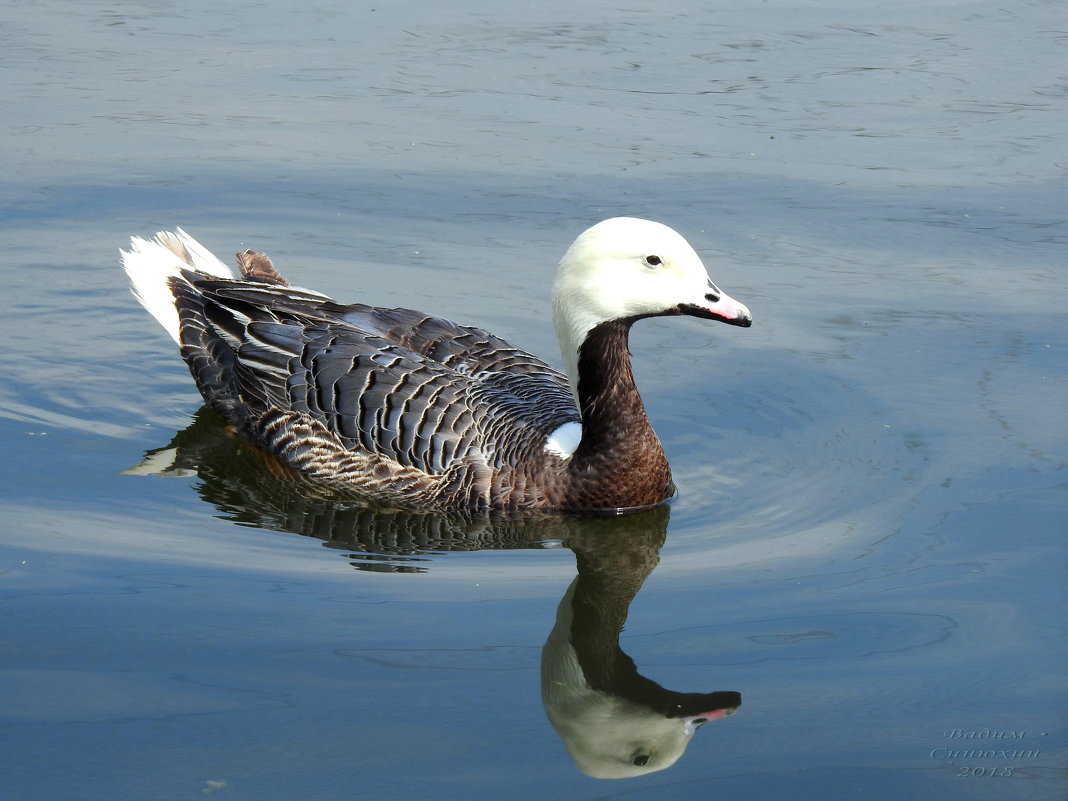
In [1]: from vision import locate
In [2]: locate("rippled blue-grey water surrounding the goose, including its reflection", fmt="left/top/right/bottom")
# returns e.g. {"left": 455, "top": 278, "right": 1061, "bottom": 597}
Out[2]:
{"left": 0, "top": 0, "right": 1068, "bottom": 801}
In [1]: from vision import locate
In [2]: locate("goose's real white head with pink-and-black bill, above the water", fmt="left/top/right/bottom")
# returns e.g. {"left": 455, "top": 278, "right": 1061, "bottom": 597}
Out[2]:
{"left": 552, "top": 217, "right": 752, "bottom": 399}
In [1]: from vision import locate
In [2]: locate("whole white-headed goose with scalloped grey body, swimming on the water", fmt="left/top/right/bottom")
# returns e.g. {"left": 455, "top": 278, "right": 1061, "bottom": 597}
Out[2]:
{"left": 120, "top": 217, "right": 752, "bottom": 514}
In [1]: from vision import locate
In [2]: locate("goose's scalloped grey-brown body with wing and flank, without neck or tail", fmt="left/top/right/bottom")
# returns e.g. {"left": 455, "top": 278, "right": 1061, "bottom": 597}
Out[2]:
{"left": 172, "top": 270, "right": 579, "bottom": 508}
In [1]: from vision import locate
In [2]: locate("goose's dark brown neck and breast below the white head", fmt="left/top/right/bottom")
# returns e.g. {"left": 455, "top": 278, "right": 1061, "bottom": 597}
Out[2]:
{"left": 569, "top": 318, "right": 672, "bottom": 508}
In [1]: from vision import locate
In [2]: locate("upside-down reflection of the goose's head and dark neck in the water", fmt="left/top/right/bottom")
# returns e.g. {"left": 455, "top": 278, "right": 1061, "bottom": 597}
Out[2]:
{"left": 541, "top": 516, "right": 741, "bottom": 779}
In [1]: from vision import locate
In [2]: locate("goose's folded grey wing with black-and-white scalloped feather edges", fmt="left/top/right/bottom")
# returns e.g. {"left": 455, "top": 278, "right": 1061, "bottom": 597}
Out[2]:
{"left": 175, "top": 273, "right": 579, "bottom": 474}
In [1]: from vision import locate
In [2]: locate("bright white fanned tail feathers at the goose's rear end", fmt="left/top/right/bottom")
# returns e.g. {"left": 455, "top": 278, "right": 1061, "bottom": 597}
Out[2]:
{"left": 120, "top": 229, "right": 234, "bottom": 342}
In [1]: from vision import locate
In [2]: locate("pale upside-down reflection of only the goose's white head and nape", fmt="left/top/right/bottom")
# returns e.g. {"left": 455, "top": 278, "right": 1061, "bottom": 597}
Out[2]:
{"left": 541, "top": 579, "right": 734, "bottom": 779}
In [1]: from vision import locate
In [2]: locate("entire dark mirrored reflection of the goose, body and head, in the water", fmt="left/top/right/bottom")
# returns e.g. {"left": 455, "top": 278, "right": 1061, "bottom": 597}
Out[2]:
{"left": 127, "top": 408, "right": 741, "bottom": 779}
